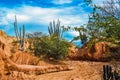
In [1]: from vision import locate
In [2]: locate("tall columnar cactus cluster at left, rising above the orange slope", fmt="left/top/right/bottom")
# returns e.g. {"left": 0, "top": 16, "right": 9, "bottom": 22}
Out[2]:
{"left": 14, "top": 16, "right": 25, "bottom": 51}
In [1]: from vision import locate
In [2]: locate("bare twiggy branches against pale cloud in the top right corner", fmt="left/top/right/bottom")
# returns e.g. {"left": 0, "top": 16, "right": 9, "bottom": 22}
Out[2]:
{"left": 101, "top": 0, "right": 120, "bottom": 20}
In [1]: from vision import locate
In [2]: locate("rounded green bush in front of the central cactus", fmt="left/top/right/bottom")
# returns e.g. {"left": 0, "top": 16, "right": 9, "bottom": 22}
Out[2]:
{"left": 34, "top": 35, "right": 70, "bottom": 60}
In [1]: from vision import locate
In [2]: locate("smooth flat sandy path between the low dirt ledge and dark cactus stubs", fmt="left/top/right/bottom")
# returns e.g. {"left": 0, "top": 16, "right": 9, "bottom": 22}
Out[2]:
{"left": 35, "top": 61, "right": 108, "bottom": 80}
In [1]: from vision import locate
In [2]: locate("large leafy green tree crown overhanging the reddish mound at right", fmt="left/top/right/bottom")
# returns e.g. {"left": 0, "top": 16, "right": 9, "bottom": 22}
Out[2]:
{"left": 84, "top": 0, "right": 120, "bottom": 43}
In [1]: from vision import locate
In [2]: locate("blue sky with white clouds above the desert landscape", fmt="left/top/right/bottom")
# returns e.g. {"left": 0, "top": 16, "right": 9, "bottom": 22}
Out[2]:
{"left": 0, "top": 0, "right": 103, "bottom": 45}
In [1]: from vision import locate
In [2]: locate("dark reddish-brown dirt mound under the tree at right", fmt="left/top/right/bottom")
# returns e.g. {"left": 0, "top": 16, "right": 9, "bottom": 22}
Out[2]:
{"left": 69, "top": 42, "right": 110, "bottom": 61}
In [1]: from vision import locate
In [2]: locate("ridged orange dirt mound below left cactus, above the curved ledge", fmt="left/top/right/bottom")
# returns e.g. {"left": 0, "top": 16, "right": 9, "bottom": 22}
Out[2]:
{"left": 10, "top": 51, "right": 57, "bottom": 66}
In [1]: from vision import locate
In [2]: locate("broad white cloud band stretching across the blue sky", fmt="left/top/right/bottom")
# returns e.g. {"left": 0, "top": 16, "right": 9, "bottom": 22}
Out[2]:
{"left": 0, "top": 5, "right": 88, "bottom": 35}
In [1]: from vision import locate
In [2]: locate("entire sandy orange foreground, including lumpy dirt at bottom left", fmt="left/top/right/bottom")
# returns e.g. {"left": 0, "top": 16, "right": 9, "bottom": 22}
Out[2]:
{"left": 3, "top": 61, "right": 120, "bottom": 80}
